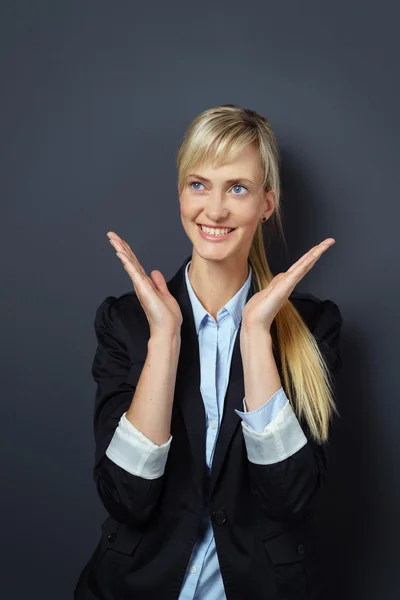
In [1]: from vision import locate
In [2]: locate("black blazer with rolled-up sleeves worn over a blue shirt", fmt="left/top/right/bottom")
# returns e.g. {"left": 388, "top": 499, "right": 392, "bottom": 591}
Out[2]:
{"left": 74, "top": 256, "right": 342, "bottom": 600}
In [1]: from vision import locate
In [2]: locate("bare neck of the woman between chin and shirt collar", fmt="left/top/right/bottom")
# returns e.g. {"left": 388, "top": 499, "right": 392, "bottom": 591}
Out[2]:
{"left": 188, "top": 253, "right": 249, "bottom": 320}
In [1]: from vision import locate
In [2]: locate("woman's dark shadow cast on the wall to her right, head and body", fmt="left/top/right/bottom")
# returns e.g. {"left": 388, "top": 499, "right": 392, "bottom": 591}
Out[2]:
{"left": 276, "top": 150, "right": 376, "bottom": 600}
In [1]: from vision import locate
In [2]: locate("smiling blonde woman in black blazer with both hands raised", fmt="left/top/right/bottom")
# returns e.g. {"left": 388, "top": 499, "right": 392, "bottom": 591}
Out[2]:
{"left": 74, "top": 105, "right": 342, "bottom": 600}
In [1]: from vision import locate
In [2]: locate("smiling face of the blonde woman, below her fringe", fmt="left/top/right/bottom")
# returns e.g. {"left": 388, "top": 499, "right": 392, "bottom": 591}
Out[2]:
{"left": 180, "top": 144, "right": 274, "bottom": 260}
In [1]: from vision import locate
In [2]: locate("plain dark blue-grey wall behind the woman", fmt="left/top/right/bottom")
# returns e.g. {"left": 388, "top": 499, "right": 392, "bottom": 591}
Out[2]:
{"left": 0, "top": 0, "right": 400, "bottom": 600}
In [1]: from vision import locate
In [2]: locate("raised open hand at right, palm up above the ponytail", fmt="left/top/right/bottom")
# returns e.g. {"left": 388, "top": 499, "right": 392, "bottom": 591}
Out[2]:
{"left": 242, "top": 238, "right": 335, "bottom": 333}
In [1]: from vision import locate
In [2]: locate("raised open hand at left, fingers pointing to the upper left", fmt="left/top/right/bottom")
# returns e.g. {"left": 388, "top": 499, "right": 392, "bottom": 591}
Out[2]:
{"left": 107, "top": 231, "right": 183, "bottom": 336}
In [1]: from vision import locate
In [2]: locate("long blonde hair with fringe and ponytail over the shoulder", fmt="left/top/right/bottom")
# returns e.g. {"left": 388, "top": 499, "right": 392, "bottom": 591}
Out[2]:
{"left": 177, "top": 104, "right": 339, "bottom": 443}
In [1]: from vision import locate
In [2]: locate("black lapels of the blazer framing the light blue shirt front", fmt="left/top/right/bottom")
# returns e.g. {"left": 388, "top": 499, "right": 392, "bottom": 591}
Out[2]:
{"left": 168, "top": 256, "right": 280, "bottom": 497}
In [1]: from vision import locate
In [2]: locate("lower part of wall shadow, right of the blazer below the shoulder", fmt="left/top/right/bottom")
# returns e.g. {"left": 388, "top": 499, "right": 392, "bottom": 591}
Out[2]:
{"left": 316, "top": 328, "right": 376, "bottom": 600}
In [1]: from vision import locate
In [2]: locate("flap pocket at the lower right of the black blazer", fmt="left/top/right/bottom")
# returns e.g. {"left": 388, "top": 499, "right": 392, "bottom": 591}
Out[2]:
{"left": 263, "top": 531, "right": 315, "bottom": 600}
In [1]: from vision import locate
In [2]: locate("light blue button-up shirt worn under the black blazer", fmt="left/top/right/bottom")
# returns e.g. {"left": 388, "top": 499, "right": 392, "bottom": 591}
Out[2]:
{"left": 179, "top": 261, "right": 288, "bottom": 600}
